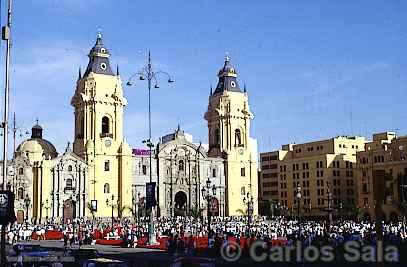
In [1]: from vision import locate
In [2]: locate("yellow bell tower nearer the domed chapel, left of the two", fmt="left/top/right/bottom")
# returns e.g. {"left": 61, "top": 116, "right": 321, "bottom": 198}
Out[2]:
{"left": 71, "top": 33, "right": 132, "bottom": 216}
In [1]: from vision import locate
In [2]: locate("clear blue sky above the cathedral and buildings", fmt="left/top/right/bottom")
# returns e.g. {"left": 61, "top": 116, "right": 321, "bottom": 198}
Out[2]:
{"left": 0, "top": 0, "right": 407, "bottom": 152}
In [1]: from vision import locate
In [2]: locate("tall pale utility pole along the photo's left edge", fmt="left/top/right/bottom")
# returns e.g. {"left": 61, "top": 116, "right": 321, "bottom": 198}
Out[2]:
{"left": 1, "top": 0, "right": 12, "bottom": 266}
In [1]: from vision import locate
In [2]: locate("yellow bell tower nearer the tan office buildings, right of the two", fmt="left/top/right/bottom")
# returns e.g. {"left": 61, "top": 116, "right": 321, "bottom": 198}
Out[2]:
{"left": 205, "top": 56, "right": 258, "bottom": 218}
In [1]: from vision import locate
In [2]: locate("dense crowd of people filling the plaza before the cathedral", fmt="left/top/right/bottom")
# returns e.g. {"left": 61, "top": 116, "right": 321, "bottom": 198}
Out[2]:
{"left": 3, "top": 216, "right": 407, "bottom": 253}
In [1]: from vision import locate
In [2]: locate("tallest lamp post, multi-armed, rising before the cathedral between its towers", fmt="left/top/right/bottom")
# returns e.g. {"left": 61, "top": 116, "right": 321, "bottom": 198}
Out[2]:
{"left": 126, "top": 51, "right": 174, "bottom": 244}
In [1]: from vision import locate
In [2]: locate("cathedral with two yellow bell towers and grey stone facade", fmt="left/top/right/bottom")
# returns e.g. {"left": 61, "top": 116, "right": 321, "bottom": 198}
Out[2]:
{"left": 6, "top": 34, "right": 258, "bottom": 223}
